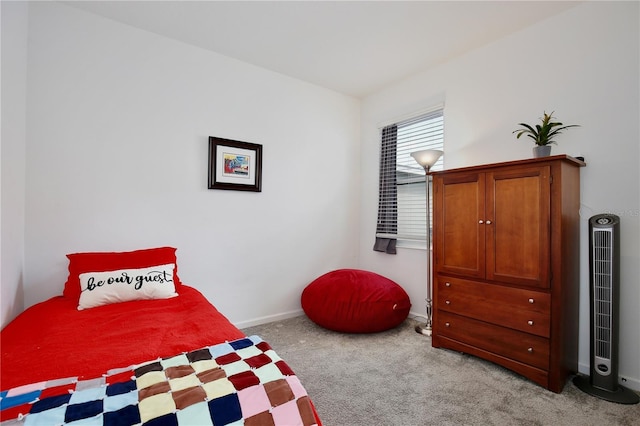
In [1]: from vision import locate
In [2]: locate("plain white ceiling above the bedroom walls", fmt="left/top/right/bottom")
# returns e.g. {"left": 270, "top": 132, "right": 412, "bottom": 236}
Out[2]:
{"left": 64, "top": 0, "right": 580, "bottom": 98}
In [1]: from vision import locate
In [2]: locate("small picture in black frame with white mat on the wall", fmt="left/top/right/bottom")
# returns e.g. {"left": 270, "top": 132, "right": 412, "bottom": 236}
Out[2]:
{"left": 209, "top": 136, "right": 262, "bottom": 192}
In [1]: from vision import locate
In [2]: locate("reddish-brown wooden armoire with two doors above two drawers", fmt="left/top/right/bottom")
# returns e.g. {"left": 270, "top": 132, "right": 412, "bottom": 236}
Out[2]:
{"left": 432, "top": 155, "right": 585, "bottom": 393}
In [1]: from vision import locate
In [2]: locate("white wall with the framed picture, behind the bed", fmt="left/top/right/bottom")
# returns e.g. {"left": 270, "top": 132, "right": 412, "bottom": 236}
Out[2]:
{"left": 25, "top": 2, "right": 360, "bottom": 326}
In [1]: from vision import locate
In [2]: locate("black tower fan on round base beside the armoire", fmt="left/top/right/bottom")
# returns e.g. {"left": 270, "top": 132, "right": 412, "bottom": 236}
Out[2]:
{"left": 573, "top": 214, "right": 640, "bottom": 404}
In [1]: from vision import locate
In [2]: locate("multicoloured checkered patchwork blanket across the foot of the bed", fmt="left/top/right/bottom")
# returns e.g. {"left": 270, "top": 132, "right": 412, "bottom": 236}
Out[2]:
{"left": 0, "top": 336, "right": 318, "bottom": 426}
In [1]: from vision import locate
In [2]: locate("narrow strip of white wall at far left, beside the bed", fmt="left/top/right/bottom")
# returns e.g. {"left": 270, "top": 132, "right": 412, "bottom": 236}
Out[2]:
{"left": 0, "top": 1, "right": 28, "bottom": 326}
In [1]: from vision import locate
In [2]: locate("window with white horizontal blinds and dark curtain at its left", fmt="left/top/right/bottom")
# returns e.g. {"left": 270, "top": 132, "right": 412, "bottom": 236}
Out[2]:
{"left": 374, "top": 108, "right": 444, "bottom": 253}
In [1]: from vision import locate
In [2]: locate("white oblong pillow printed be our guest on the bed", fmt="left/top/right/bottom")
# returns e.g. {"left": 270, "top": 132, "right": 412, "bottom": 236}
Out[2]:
{"left": 78, "top": 263, "right": 178, "bottom": 310}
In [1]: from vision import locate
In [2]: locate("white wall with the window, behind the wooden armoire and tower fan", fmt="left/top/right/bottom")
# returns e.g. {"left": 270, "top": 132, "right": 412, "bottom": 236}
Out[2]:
{"left": 360, "top": 2, "right": 640, "bottom": 390}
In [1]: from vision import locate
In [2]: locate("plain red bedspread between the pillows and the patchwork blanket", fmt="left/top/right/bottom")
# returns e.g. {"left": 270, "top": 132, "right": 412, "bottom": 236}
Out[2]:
{"left": 0, "top": 286, "right": 244, "bottom": 389}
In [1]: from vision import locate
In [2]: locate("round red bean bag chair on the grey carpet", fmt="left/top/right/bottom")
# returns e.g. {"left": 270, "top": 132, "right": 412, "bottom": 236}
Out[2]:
{"left": 301, "top": 269, "right": 411, "bottom": 333}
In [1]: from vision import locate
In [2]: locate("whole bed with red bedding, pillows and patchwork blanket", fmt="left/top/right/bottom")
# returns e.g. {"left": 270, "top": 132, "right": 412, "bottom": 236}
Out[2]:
{"left": 0, "top": 247, "right": 321, "bottom": 426}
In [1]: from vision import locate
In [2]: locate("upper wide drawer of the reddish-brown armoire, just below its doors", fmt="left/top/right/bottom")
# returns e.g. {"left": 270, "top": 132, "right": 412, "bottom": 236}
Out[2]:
{"left": 435, "top": 276, "right": 551, "bottom": 337}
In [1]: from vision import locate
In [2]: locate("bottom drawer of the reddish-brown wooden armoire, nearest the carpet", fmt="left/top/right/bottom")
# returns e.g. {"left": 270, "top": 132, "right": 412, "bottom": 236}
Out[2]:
{"left": 435, "top": 311, "right": 549, "bottom": 370}
